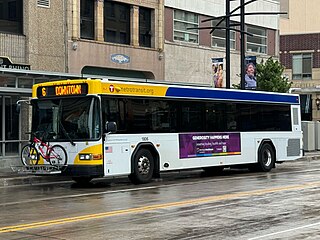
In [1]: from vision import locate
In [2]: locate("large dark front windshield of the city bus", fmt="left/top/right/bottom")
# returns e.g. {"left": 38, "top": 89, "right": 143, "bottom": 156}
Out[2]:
{"left": 32, "top": 97, "right": 101, "bottom": 142}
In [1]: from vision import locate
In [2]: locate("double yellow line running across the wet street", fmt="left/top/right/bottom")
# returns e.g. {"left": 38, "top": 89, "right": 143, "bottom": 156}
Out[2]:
{"left": 0, "top": 182, "right": 320, "bottom": 233}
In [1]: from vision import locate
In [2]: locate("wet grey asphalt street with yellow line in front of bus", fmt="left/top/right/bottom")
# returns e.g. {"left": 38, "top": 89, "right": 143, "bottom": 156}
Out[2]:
{"left": 0, "top": 160, "right": 320, "bottom": 240}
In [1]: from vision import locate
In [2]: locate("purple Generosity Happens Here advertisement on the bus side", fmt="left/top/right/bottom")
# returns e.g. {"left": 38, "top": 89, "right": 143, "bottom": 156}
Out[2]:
{"left": 179, "top": 132, "right": 241, "bottom": 158}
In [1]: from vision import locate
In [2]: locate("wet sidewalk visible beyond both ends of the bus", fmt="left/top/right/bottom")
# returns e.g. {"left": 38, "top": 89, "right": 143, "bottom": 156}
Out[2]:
{"left": 0, "top": 151, "right": 320, "bottom": 188}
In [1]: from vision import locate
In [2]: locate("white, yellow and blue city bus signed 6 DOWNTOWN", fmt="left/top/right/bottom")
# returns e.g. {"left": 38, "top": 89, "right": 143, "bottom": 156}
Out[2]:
{"left": 18, "top": 79, "right": 303, "bottom": 184}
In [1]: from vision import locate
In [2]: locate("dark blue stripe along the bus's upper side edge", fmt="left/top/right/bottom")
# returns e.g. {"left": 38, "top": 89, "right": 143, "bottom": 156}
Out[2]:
{"left": 166, "top": 87, "right": 299, "bottom": 104}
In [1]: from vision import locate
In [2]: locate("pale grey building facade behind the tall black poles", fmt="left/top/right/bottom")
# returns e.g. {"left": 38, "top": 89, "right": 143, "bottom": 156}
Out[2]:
{"left": 164, "top": 0, "right": 280, "bottom": 87}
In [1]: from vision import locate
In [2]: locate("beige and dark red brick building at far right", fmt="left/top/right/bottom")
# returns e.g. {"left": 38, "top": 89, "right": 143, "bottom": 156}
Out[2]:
{"left": 280, "top": 0, "right": 320, "bottom": 120}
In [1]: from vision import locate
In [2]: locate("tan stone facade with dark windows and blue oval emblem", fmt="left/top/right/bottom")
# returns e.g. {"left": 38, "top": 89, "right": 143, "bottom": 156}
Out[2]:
{"left": 67, "top": 0, "right": 164, "bottom": 80}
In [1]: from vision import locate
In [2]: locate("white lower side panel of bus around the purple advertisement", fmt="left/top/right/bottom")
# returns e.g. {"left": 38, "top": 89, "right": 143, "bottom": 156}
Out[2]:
{"left": 104, "top": 132, "right": 302, "bottom": 176}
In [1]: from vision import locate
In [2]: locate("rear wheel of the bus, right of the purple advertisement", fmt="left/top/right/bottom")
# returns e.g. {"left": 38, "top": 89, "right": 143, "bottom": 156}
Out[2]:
{"left": 256, "top": 143, "right": 276, "bottom": 172}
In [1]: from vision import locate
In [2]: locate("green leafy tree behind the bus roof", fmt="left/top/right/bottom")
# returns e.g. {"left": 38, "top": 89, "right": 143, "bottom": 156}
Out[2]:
{"left": 256, "top": 57, "right": 292, "bottom": 93}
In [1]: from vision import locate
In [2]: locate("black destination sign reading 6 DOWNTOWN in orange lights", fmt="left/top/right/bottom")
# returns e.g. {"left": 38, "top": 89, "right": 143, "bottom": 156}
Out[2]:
{"left": 37, "top": 83, "right": 88, "bottom": 98}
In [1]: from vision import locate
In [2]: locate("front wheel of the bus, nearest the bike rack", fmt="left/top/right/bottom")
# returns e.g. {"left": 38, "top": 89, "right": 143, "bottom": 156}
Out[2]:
{"left": 129, "top": 148, "right": 154, "bottom": 184}
